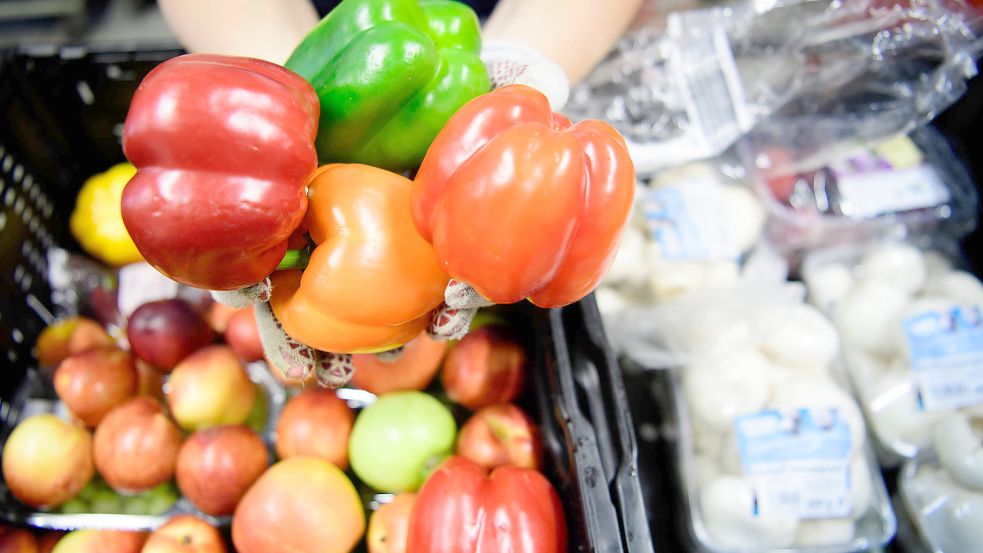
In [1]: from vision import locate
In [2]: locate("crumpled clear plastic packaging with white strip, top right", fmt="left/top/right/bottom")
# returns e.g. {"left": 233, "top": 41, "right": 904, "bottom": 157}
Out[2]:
{"left": 567, "top": 0, "right": 981, "bottom": 174}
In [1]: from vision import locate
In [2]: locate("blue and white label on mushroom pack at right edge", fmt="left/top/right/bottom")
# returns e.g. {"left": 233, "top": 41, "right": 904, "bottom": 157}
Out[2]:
{"left": 903, "top": 306, "right": 983, "bottom": 411}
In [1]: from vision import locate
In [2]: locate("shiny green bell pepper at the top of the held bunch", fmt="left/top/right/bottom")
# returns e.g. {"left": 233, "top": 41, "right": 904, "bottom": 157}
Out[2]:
{"left": 286, "top": 0, "right": 491, "bottom": 171}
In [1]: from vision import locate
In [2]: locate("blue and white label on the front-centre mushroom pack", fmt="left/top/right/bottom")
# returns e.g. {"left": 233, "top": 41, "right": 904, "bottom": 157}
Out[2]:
{"left": 734, "top": 409, "right": 853, "bottom": 519}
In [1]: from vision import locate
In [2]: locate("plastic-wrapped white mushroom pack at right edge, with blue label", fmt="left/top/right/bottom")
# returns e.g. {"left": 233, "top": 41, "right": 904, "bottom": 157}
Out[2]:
{"left": 802, "top": 238, "right": 983, "bottom": 467}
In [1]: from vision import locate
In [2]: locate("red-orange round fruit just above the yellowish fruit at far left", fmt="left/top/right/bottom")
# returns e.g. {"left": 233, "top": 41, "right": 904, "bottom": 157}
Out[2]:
{"left": 54, "top": 346, "right": 138, "bottom": 427}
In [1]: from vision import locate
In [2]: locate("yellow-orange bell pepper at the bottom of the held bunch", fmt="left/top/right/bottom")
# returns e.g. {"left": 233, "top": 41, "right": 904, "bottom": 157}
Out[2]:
{"left": 270, "top": 164, "right": 447, "bottom": 353}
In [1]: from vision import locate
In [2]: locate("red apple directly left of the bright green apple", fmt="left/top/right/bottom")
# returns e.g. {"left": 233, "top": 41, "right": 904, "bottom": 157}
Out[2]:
{"left": 276, "top": 388, "right": 355, "bottom": 469}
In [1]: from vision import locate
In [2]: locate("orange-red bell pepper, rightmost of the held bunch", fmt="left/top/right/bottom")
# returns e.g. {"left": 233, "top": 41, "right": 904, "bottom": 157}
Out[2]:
{"left": 413, "top": 85, "right": 635, "bottom": 307}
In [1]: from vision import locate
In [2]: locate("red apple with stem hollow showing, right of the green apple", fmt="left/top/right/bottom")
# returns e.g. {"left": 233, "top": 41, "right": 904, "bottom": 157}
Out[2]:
{"left": 457, "top": 403, "right": 542, "bottom": 470}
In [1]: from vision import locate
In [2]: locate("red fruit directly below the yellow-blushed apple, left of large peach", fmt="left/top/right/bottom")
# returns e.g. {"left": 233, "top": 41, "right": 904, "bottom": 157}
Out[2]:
{"left": 177, "top": 425, "right": 270, "bottom": 516}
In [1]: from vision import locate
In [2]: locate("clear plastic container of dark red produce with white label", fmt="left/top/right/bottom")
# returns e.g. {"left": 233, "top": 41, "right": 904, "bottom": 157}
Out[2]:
{"left": 745, "top": 127, "right": 978, "bottom": 258}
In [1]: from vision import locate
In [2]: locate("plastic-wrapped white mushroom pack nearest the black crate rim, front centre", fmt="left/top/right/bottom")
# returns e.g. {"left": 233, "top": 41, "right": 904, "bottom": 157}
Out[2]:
{"left": 610, "top": 282, "right": 896, "bottom": 552}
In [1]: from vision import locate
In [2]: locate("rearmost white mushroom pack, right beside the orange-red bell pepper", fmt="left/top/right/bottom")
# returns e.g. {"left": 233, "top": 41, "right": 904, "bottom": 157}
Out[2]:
{"left": 596, "top": 157, "right": 787, "bottom": 324}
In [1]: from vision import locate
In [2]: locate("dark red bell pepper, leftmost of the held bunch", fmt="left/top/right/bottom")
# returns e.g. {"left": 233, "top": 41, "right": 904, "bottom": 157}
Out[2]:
{"left": 122, "top": 54, "right": 318, "bottom": 290}
